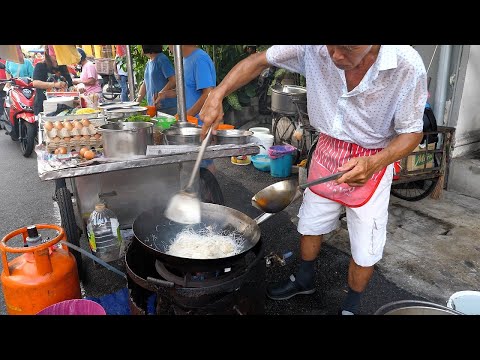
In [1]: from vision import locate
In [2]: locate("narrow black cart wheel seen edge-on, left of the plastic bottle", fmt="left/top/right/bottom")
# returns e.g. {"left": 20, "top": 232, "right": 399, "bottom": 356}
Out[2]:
{"left": 55, "top": 187, "right": 85, "bottom": 280}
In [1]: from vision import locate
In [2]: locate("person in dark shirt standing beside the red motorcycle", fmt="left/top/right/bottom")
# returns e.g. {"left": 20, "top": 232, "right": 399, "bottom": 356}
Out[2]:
{"left": 33, "top": 45, "right": 73, "bottom": 115}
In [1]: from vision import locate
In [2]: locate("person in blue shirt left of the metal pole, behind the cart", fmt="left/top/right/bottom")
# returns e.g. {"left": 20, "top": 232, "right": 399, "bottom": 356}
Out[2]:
{"left": 137, "top": 45, "right": 177, "bottom": 115}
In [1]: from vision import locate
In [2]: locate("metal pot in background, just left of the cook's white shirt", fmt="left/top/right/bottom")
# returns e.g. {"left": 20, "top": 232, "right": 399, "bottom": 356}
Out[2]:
{"left": 271, "top": 85, "right": 307, "bottom": 115}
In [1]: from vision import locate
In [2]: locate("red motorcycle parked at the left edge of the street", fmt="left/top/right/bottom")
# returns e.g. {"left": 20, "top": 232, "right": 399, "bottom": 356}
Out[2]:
{"left": 0, "top": 77, "right": 38, "bottom": 157}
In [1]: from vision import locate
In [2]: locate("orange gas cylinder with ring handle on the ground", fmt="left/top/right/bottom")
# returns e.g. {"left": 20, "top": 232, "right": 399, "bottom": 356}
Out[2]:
{"left": 0, "top": 224, "right": 81, "bottom": 315}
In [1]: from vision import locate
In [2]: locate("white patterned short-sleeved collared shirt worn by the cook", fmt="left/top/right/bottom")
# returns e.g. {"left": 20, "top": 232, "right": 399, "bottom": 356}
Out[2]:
{"left": 266, "top": 45, "right": 427, "bottom": 149}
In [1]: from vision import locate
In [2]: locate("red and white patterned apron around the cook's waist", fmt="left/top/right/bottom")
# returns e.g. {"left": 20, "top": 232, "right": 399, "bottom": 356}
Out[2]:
{"left": 308, "top": 134, "right": 386, "bottom": 207}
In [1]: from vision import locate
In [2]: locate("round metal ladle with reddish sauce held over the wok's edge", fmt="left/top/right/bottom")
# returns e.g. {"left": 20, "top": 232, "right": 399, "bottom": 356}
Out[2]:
{"left": 252, "top": 171, "right": 346, "bottom": 213}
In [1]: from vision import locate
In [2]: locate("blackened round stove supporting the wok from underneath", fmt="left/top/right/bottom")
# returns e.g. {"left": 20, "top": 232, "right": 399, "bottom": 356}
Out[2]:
{"left": 125, "top": 240, "right": 266, "bottom": 315}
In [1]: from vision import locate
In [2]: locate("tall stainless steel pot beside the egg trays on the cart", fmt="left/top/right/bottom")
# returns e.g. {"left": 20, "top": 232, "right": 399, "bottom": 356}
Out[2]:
{"left": 98, "top": 122, "right": 153, "bottom": 159}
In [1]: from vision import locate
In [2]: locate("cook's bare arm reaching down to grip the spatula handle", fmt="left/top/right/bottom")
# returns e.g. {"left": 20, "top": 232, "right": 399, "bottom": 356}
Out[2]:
{"left": 200, "top": 51, "right": 270, "bottom": 138}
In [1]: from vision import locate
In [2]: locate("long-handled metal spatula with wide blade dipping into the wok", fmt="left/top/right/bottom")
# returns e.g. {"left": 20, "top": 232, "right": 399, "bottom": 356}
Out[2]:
{"left": 165, "top": 127, "right": 212, "bottom": 224}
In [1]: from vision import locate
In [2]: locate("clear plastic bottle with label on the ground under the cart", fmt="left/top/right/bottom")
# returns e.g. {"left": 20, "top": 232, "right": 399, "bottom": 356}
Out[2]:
{"left": 87, "top": 204, "right": 124, "bottom": 262}
